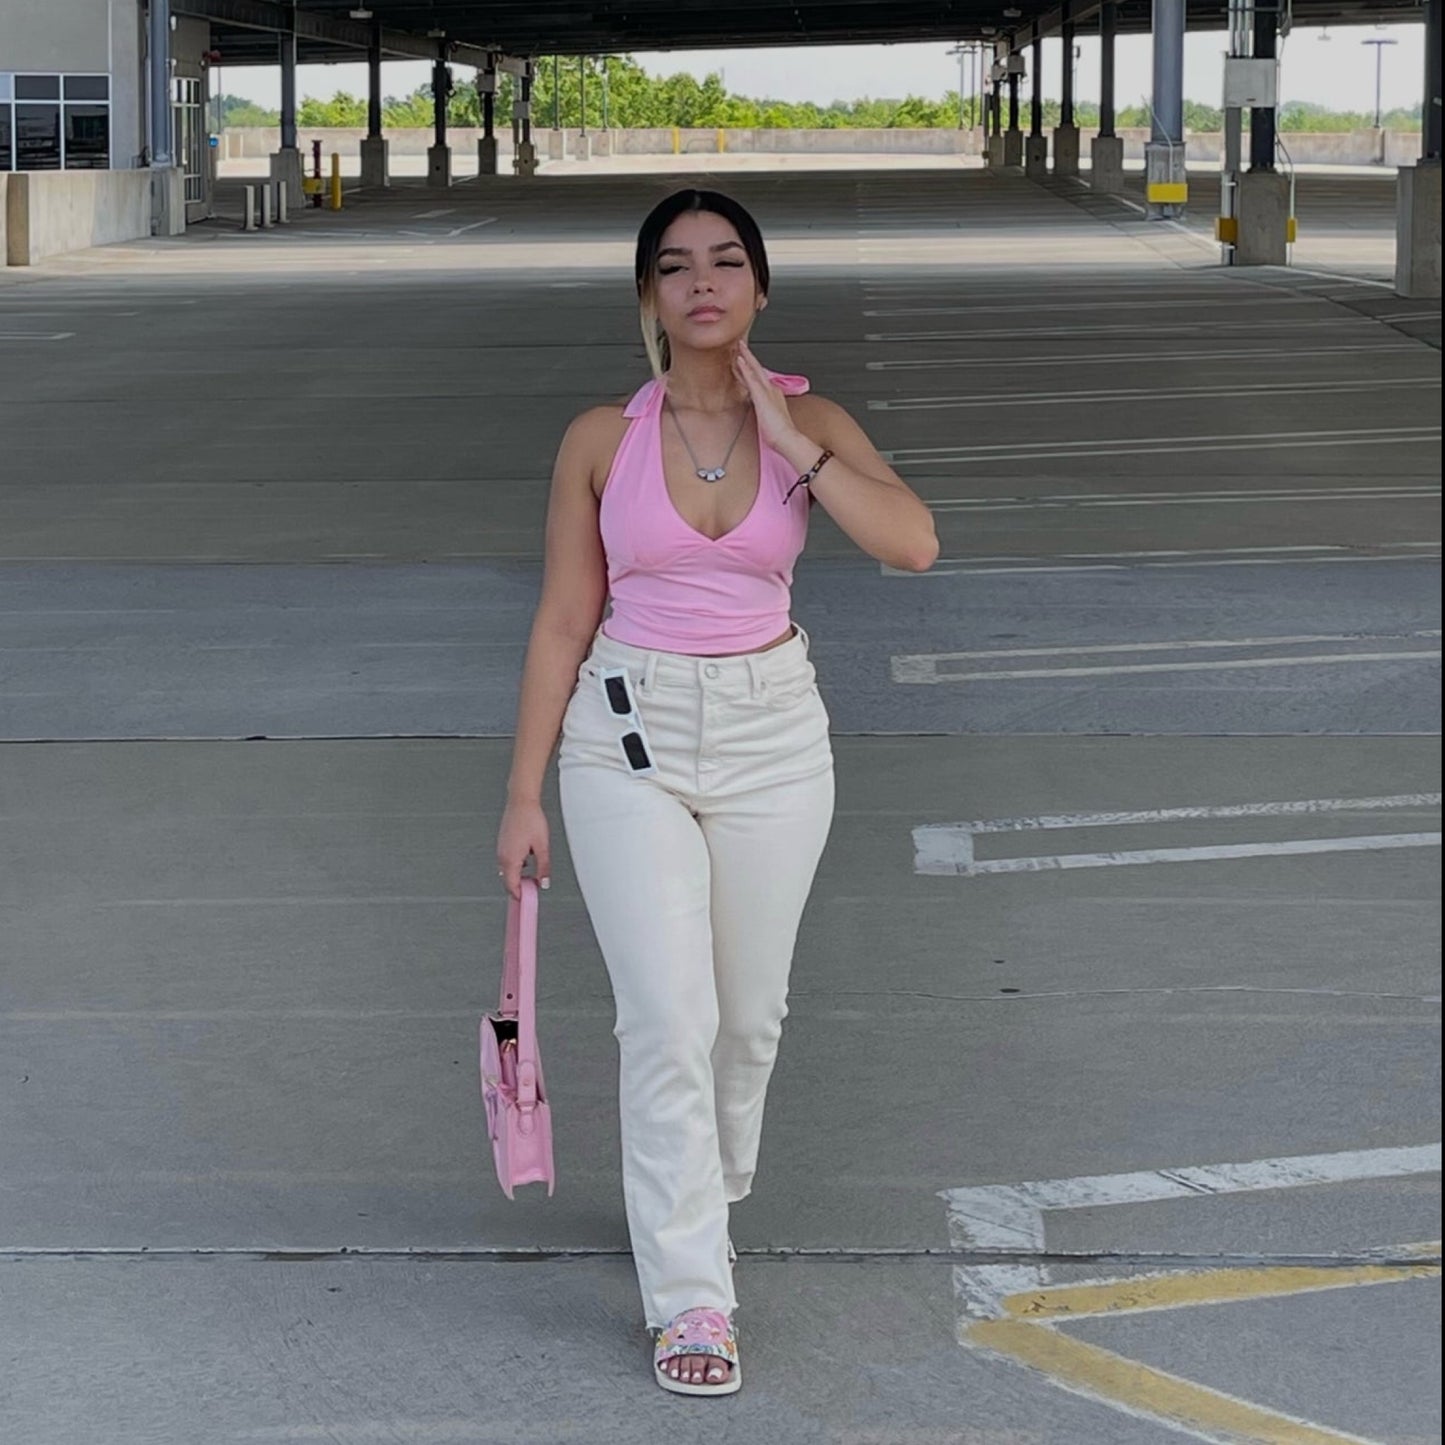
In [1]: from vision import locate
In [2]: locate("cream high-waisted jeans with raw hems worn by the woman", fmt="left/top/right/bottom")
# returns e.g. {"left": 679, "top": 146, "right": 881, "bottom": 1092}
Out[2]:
{"left": 558, "top": 630, "right": 834, "bottom": 1328}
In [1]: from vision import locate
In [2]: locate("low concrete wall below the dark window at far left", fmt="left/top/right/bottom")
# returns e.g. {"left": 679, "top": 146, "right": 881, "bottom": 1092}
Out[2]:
{"left": 6, "top": 171, "right": 150, "bottom": 266}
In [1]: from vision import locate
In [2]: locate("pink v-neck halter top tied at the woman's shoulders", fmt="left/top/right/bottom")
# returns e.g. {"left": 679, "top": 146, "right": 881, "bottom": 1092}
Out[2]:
{"left": 600, "top": 373, "right": 812, "bottom": 655}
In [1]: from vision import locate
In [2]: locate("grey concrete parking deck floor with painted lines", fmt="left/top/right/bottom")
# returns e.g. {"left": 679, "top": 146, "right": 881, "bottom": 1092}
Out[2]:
{"left": 0, "top": 169, "right": 1441, "bottom": 1445}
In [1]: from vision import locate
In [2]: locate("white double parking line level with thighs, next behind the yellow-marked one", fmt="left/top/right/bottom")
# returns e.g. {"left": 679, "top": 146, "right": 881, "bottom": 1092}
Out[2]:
{"left": 913, "top": 793, "right": 1441, "bottom": 879}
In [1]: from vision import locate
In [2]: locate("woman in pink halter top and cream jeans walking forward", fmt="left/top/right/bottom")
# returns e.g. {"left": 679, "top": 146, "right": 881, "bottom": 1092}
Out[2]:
{"left": 497, "top": 191, "right": 938, "bottom": 1394}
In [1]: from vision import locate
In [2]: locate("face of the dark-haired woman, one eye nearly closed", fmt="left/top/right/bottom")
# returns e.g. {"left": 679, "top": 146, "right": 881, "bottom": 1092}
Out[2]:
{"left": 655, "top": 211, "right": 762, "bottom": 351}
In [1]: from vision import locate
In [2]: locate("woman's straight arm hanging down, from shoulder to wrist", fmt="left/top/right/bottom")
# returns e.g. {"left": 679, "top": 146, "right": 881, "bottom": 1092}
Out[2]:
{"left": 507, "top": 407, "right": 618, "bottom": 805}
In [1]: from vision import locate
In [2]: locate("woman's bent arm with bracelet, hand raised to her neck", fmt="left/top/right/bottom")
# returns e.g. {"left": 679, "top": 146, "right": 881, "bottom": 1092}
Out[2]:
{"left": 738, "top": 345, "right": 938, "bottom": 572}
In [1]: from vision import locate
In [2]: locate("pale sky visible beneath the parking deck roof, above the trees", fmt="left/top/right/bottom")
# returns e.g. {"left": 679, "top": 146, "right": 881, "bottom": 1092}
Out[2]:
{"left": 221, "top": 25, "right": 1425, "bottom": 111}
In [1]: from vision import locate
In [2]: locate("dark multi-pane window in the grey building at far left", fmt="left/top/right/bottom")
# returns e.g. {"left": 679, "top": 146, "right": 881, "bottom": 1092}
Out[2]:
{"left": 0, "top": 74, "right": 110, "bottom": 171}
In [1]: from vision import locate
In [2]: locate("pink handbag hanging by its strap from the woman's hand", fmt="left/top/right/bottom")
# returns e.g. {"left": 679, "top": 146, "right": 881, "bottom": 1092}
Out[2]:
{"left": 481, "top": 879, "right": 556, "bottom": 1199}
